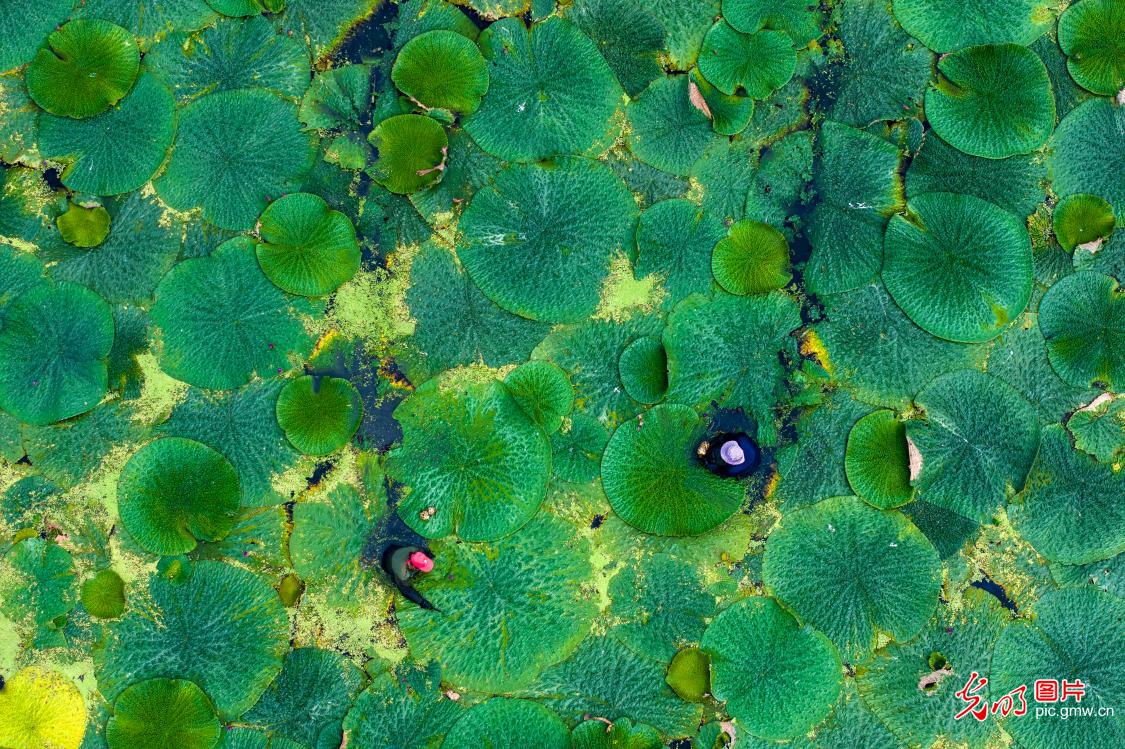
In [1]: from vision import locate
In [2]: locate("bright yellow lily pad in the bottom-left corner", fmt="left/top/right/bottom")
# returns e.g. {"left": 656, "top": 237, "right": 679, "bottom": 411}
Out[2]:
{"left": 0, "top": 666, "right": 87, "bottom": 749}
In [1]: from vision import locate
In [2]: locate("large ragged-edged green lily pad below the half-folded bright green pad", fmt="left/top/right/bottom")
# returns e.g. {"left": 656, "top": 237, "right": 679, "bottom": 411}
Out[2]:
{"left": 765, "top": 497, "right": 942, "bottom": 662}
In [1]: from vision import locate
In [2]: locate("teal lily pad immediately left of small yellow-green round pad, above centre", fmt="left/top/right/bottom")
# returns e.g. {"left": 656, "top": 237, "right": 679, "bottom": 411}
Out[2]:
{"left": 633, "top": 199, "right": 726, "bottom": 305}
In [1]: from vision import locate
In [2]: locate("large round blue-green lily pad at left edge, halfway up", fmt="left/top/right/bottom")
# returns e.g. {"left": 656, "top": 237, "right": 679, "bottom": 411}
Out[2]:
{"left": 0, "top": 281, "right": 114, "bottom": 424}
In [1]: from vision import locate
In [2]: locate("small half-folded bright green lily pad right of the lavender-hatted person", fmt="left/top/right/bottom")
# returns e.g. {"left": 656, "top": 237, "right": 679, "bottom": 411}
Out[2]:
{"left": 844, "top": 410, "right": 914, "bottom": 509}
